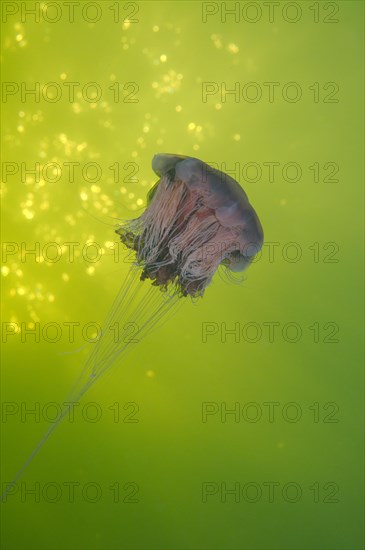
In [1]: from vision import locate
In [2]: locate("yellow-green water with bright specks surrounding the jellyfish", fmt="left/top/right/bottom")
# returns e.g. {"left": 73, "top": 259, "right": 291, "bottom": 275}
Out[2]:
{"left": 1, "top": 1, "right": 363, "bottom": 550}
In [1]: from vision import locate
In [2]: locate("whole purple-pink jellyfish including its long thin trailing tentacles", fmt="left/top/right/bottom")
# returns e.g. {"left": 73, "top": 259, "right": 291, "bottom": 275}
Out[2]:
{"left": 2, "top": 154, "right": 263, "bottom": 500}
